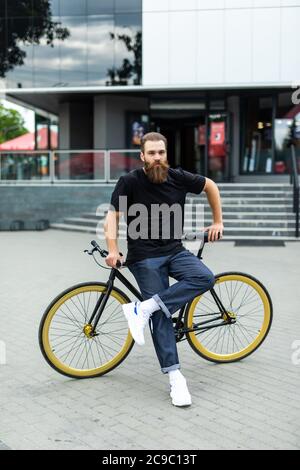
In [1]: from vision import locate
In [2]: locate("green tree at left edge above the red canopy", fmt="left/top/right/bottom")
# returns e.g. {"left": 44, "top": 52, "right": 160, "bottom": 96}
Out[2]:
{"left": 0, "top": 103, "right": 29, "bottom": 144}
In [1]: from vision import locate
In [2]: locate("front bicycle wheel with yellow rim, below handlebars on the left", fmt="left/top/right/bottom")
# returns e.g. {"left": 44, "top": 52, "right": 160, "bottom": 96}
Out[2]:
{"left": 39, "top": 282, "right": 134, "bottom": 378}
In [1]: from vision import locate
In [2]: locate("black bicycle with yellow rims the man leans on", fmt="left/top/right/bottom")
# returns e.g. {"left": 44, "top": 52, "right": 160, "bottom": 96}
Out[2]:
{"left": 39, "top": 232, "right": 273, "bottom": 378}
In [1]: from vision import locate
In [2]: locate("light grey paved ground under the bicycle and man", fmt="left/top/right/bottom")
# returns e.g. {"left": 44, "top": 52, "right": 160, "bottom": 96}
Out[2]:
{"left": 0, "top": 230, "right": 300, "bottom": 450}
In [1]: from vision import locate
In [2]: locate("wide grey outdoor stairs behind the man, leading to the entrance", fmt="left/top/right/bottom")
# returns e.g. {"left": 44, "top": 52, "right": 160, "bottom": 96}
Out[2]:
{"left": 50, "top": 183, "right": 299, "bottom": 241}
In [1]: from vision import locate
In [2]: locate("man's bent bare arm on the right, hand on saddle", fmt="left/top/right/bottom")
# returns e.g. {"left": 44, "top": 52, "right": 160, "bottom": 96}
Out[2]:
{"left": 203, "top": 178, "right": 224, "bottom": 242}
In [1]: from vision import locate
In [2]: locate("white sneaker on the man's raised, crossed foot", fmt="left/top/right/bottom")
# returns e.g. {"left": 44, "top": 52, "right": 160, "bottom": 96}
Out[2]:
{"left": 122, "top": 302, "right": 151, "bottom": 346}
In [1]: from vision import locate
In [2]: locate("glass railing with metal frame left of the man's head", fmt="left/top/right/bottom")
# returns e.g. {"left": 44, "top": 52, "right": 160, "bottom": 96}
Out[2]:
{"left": 0, "top": 149, "right": 142, "bottom": 184}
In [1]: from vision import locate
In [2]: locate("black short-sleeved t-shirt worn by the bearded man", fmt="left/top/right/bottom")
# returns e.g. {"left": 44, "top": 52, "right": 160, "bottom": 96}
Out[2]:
{"left": 110, "top": 168, "right": 205, "bottom": 264}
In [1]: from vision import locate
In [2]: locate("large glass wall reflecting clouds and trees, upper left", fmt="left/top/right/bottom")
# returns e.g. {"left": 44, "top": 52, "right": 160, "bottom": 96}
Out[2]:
{"left": 0, "top": 0, "right": 142, "bottom": 88}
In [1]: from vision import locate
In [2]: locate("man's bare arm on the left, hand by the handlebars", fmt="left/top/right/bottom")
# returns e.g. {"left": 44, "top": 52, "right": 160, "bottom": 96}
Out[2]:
{"left": 104, "top": 211, "right": 124, "bottom": 268}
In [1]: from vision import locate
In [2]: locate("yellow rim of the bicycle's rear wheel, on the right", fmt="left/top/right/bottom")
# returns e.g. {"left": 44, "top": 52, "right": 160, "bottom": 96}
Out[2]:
{"left": 187, "top": 274, "right": 271, "bottom": 362}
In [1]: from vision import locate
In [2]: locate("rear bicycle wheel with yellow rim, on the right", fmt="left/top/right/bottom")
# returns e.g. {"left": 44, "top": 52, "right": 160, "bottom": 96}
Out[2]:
{"left": 185, "top": 272, "right": 273, "bottom": 363}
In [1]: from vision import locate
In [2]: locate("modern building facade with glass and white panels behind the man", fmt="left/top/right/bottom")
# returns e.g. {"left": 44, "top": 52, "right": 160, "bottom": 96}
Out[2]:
{"left": 0, "top": 0, "right": 300, "bottom": 182}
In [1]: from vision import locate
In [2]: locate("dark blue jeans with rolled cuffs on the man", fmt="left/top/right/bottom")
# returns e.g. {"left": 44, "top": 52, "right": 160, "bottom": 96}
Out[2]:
{"left": 128, "top": 250, "right": 215, "bottom": 373}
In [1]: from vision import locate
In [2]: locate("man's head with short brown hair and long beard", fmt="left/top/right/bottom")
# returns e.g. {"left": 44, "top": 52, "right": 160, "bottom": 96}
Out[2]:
{"left": 141, "top": 140, "right": 170, "bottom": 184}
